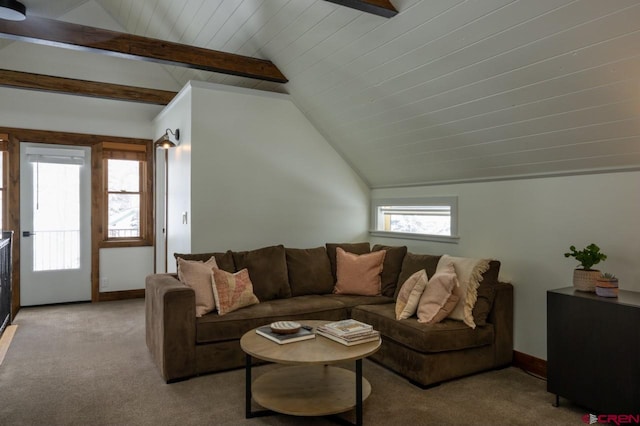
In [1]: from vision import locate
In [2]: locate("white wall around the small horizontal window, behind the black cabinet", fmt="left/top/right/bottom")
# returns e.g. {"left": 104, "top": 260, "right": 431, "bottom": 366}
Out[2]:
{"left": 372, "top": 172, "right": 640, "bottom": 359}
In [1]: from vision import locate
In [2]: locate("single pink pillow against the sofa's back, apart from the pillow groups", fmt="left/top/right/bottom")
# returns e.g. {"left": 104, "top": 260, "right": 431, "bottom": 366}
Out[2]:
{"left": 333, "top": 247, "right": 387, "bottom": 296}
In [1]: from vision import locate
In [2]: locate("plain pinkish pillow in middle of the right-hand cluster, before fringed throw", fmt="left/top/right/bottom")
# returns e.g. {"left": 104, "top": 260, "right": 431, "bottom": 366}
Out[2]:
{"left": 418, "top": 263, "right": 460, "bottom": 324}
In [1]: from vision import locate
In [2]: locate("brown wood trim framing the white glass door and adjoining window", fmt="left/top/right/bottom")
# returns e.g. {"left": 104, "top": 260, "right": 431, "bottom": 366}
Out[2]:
{"left": 0, "top": 127, "right": 153, "bottom": 317}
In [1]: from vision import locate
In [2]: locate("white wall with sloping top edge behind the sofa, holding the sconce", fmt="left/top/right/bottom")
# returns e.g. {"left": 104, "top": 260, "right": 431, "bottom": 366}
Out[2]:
{"left": 156, "top": 82, "right": 369, "bottom": 270}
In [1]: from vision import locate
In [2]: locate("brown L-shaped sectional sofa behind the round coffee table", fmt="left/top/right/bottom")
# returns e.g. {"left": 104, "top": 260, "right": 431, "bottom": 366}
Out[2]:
{"left": 146, "top": 243, "right": 513, "bottom": 387}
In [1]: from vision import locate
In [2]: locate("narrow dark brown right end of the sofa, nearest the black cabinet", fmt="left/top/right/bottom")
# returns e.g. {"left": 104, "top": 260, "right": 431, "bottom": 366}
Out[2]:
{"left": 487, "top": 282, "right": 513, "bottom": 366}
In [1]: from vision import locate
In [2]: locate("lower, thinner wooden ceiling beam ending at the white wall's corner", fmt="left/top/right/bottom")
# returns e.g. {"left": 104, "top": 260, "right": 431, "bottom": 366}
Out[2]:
{"left": 0, "top": 69, "right": 177, "bottom": 105}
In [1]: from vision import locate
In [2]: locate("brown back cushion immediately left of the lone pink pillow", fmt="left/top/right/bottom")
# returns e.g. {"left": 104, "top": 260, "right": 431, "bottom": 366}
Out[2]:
{"left": 285, "top": 247, "right": 334, "bottom": 296}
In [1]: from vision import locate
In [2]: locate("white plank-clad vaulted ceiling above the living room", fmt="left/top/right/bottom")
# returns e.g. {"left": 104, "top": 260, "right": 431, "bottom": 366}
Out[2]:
{"left": 4, "top": 0, "right": 640, "bottom": 188}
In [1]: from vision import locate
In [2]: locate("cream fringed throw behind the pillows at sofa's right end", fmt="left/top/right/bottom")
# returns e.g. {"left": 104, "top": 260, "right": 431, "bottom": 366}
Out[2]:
{"left": 436, "top": 254, "right": 490, "bottom": 328}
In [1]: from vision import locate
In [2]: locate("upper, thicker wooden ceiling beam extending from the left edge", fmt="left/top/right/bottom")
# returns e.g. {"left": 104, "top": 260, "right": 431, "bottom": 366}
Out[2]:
{"left": 0, "top": 16, "right": 287, "bottom": 83}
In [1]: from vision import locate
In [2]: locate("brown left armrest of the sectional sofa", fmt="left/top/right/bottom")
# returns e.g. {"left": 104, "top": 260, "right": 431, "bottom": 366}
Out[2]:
{"left": 145, "top": 274, "right": 196, "bottom": 383}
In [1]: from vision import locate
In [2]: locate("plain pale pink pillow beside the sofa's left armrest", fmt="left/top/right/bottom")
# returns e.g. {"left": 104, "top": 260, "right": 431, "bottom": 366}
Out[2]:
{"left": 178, "top": 256, "right": 218, "bottom": 317}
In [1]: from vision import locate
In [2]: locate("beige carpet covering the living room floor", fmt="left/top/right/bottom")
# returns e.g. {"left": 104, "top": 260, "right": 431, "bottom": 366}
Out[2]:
{"left": 0, "top": 300, "right": 586, "bottom": 425}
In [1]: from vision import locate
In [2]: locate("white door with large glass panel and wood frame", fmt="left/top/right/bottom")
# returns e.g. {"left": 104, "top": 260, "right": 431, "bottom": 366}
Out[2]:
{"left": 19, "top": 143, "right": 91, "bottom": 306}
